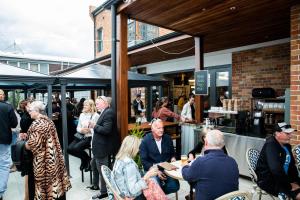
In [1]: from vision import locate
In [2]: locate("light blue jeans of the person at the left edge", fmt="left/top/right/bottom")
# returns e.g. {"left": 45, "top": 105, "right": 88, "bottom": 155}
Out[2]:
{"left": 0, "top": 144, "right": 11, "bottom": 197}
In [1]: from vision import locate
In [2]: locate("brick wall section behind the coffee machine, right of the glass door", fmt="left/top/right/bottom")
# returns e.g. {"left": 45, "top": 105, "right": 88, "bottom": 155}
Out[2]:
{"left": 232, "top": 43, "right": 290, "bottom": 110}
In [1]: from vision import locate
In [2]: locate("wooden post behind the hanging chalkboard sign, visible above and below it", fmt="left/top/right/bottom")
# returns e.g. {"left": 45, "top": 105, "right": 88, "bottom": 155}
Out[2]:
{"left": 195, "top": 37, "right": 204, "bottom": 123}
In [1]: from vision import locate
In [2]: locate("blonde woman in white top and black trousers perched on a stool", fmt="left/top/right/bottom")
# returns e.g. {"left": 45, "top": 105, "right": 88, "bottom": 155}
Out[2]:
{"left": 68, "top": 99, "right": 99, "bottom": 171}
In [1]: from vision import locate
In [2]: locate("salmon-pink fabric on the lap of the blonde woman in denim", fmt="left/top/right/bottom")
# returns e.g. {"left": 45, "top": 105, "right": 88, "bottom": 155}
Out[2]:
{"left": 143, "top": 179, "right": 168, "bottom": 200}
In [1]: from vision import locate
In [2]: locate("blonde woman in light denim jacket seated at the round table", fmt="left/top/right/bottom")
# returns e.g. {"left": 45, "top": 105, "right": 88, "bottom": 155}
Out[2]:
{"left": 112, "top": 135, "right": 162, "bottom": 199}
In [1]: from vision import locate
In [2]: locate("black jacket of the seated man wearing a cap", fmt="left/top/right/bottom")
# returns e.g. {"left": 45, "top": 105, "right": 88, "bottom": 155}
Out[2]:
{"left": 255, "top": 136, "right": 300, "bottom": 196}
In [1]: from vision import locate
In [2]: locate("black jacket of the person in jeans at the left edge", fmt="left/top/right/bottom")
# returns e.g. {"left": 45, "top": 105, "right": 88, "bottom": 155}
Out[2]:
{"left": 0, "top": 101, "right": 18, "bottom": 144}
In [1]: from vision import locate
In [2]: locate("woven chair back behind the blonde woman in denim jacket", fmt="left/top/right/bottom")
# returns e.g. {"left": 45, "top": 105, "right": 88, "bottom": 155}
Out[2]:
{"left": 101, "top": 165, "right": 124, "bottom": 200}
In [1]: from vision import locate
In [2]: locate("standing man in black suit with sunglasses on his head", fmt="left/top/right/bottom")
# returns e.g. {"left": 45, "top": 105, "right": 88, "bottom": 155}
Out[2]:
{"left": 90, "top": 96, "right": 118, "bottom": 199}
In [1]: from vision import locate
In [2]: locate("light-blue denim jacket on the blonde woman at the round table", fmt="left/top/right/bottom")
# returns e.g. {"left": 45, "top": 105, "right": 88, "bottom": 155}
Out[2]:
{"left": 112, "top": 157, "right": 147, "bottom": 198}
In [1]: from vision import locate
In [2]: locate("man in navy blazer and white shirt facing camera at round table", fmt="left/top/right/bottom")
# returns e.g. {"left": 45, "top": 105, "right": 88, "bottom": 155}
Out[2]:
{"left": 140, "top": 119, "right": 179, "bottom": 194}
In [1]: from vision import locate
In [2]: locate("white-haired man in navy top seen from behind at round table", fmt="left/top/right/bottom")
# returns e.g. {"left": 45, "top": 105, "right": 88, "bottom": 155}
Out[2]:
{"left": 182, "top": 130, "right": 239, "bottom": 200}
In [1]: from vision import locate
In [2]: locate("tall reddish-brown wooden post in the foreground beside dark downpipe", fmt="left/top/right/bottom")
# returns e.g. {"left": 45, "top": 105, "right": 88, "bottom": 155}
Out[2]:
{"left": 116, "top": 13, "right": 129, "bottom": 140}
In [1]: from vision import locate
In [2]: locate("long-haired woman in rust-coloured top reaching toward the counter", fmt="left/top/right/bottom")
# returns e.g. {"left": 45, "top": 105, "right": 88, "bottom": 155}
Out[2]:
{"left": 152, "top": 97, "right": 185, "bottom": 121}
